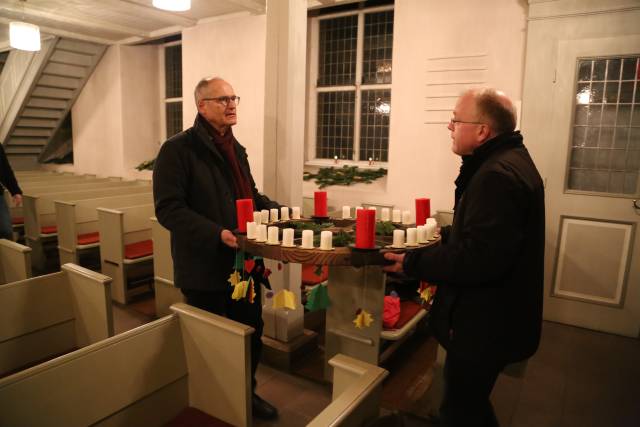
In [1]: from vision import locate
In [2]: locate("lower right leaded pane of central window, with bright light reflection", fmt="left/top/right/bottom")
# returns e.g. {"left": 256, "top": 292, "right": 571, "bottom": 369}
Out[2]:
{"left": 360, "top": 89, "right": 391, "bottom": 162}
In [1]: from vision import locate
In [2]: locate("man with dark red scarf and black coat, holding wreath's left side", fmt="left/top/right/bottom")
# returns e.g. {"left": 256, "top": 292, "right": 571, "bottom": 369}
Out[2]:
{"left": 153, "top": 77, "right": 279, "bottom": 419}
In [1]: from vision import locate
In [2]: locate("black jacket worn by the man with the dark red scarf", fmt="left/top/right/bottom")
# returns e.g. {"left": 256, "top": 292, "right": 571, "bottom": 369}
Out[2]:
{"left": 153, "top": 118, "right": 278, "bottom": 290}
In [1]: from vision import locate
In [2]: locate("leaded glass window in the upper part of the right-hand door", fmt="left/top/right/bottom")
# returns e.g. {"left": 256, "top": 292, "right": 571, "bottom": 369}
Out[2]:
{"left": 567, "top": 55, "right": 640, "bottom": 197}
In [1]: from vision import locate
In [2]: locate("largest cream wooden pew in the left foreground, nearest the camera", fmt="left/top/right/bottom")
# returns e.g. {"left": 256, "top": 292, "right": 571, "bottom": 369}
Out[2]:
{"left": 0, "top": 304, "right": 254, "bottom": 427}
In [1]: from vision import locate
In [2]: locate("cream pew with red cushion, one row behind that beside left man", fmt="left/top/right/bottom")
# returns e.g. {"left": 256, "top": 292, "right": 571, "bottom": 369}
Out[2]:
{"left": 54, "top": 193, "right": 155, "bottom": 264}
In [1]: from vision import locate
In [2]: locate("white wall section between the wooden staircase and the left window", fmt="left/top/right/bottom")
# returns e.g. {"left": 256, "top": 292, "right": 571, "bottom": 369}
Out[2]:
{"left": 71, "top": 46, "right": 160, "bottom": 179}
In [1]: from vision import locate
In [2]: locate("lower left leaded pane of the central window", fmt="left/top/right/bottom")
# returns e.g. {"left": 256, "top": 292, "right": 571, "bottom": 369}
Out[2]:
{"left": 316, "top": 91, "right": 355, "bottom": 160}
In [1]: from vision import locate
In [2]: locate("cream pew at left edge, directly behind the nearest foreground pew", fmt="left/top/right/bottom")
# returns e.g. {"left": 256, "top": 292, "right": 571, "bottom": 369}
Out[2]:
{"left": 0, "top": 264, "right": 113, "bottom": 378}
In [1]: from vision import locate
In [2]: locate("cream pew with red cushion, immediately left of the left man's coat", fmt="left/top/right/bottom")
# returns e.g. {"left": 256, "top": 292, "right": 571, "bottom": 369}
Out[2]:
{"left": 98, "top": 204, "right": 154, "bottom": 304}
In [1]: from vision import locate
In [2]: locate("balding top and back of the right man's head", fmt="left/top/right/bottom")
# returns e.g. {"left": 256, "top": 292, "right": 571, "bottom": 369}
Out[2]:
{"left": 463, "top": 88, "right": 517, "bottom": 136}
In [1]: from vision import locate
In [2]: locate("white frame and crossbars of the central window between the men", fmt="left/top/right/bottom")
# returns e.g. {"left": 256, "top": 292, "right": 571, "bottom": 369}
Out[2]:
{"left": 304, "top": 5, "right": 395, "bottom": 169}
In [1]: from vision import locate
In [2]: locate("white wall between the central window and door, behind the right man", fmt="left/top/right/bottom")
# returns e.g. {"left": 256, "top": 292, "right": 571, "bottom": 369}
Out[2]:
{"left": 304, "top": 0, "right": 527, "bottom": 219}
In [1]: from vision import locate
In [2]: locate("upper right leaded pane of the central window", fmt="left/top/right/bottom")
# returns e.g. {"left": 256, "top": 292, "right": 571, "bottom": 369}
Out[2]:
{"left": 362, "top": 11, "right": 393, "bottom": 84}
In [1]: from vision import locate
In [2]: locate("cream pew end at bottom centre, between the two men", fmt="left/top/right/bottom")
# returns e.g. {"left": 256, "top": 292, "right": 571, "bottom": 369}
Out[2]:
{"left": 307, "top": 354, "right": 389, "bottom": 427}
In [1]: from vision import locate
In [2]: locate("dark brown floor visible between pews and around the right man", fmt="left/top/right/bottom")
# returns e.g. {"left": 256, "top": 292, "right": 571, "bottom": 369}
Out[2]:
{"left": 114, "top": 299, "right": 640, "bottom": 427}
